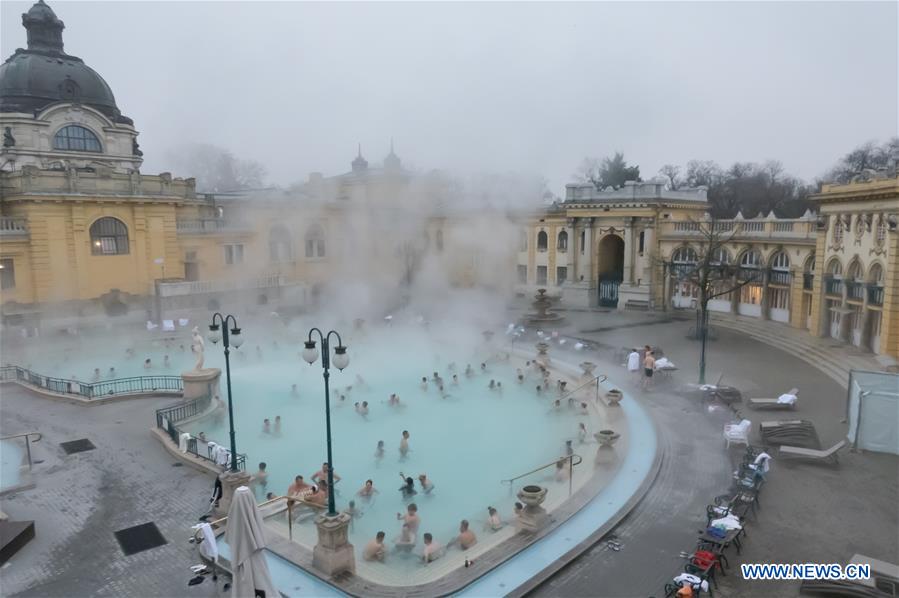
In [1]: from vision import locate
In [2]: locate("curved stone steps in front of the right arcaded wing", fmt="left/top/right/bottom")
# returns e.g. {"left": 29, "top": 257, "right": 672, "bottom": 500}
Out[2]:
{"left": 710, "top": 313, "right": 884, "bottom": 388}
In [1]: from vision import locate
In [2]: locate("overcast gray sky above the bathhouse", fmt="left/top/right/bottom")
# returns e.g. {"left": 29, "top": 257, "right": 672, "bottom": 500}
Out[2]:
{"left": 0, "top": 0, "right": 899, "bottom": 193}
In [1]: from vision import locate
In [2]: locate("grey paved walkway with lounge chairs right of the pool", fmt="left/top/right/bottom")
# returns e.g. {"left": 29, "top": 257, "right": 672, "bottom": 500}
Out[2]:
{"left": 533, "top": 313, "right": 899, "bottom": 598}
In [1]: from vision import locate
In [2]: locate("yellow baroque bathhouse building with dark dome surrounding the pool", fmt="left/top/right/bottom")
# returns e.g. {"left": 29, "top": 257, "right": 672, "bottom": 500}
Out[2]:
{"left": 0, "top": 2, "right": 899, "bottom": 366}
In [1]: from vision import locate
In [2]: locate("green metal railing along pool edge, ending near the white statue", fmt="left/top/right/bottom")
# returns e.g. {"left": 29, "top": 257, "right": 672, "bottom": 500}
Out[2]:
{"left": 0, "top": 365, "right": 184, "bottom": 399}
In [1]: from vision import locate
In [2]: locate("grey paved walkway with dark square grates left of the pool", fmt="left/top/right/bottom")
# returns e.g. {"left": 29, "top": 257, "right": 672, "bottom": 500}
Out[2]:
{"left": 0, "top": 384, "right": 221, "bottom": 597}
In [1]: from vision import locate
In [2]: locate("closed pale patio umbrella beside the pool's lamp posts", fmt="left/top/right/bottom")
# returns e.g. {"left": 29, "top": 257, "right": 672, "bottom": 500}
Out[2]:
{"left": 225, "top": 486, "right": 280, "bottom": 598}
